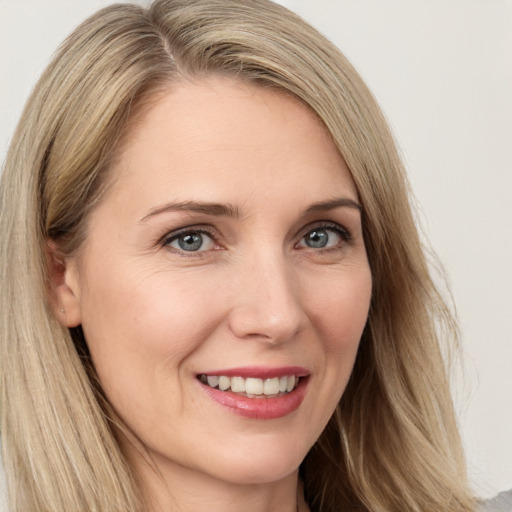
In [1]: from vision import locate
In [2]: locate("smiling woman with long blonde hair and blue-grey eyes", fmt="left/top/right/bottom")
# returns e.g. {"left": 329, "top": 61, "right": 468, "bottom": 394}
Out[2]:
{"left": 0, "top": 0, "right": 482, "bottom": 512}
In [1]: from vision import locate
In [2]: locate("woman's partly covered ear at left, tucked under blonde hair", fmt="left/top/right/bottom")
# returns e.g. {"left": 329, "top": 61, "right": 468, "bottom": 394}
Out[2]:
{"left": 46, "top": 241, "right": 82, "bottom": 327}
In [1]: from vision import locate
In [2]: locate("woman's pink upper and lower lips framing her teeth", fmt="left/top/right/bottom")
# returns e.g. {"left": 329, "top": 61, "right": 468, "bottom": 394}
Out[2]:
{"left": 197, "top": 366, "right": 309, "bottom": 420}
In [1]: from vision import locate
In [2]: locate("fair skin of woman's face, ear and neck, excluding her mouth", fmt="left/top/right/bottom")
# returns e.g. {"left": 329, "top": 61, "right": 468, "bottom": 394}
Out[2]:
{"left": 55, "top": 77, "right": 371, "bottom": 512}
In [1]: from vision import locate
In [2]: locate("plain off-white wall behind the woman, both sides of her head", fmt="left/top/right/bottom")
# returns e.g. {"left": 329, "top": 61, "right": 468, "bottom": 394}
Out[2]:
{"left": 0, "top": 0, "right": 512, "bottom": 496}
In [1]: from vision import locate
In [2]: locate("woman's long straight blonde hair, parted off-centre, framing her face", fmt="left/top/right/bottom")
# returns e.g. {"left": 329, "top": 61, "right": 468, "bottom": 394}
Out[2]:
{"left": 0, "top": 0, "right": 474, "bottom": 512}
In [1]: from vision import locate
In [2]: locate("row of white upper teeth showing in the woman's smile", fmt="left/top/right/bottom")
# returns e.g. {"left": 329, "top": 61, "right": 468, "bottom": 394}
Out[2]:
{"left": 199, "top": 375, "right": 299, "bottom": 398}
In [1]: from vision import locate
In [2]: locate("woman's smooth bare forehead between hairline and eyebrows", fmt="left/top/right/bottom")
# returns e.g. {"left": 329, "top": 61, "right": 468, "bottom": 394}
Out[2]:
{"left": 105, "top": 77, "right": 356, "bottom": 206}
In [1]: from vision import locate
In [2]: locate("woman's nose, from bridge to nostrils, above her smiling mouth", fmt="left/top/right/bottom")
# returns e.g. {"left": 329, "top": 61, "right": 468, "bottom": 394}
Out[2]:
{"left": 229, "top": 254, "right": 308, "bottom": 344}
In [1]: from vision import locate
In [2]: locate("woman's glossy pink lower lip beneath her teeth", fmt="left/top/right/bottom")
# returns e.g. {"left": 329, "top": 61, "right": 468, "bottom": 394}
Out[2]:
{"left": 198, "top": 377, "right": 309, "bottom": 420}
